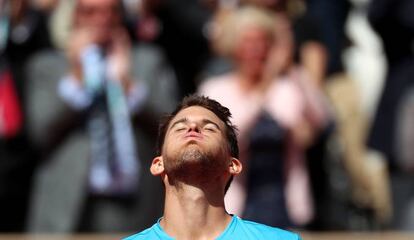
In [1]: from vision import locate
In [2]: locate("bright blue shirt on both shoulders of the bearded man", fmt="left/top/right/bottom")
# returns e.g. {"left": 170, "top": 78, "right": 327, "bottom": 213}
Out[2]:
{"left": 123, "top": 216, "right": 301, "bottom": 240}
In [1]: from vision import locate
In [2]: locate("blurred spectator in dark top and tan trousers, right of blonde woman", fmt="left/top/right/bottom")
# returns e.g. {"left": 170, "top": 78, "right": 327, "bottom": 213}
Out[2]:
{"left": 239, "top": 0, "right": 390, "bottom": 230}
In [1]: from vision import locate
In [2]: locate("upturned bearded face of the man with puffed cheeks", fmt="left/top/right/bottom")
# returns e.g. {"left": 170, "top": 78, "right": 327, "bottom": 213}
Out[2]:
{"left": 162, "top": 106, "right": 231, "bottom": 178}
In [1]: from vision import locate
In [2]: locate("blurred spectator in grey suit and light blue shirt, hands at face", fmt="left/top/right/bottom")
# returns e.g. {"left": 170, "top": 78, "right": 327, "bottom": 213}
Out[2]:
{"left": 27, "top": 0, "right": 176, "bottom": 232}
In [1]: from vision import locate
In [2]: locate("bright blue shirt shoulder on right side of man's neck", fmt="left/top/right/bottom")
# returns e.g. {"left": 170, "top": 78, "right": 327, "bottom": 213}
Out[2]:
{"left": 236, "top": 219, "right": 301, "bottom": 240}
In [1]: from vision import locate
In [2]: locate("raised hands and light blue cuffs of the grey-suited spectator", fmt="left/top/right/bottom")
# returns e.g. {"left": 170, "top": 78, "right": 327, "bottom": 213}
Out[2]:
{"left": 58, "top": 25, "right": 148, "bottom": 112}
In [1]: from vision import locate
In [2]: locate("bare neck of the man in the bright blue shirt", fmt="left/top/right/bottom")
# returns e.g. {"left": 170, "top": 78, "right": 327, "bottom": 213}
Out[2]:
{"left": 161, "top": 184, "right": 231, "bottom": 239}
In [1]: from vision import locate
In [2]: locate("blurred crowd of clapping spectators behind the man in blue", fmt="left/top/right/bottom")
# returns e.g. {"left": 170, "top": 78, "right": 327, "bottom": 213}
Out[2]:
{"left": 0, "top": 0, "right": 414, "bottom": 233}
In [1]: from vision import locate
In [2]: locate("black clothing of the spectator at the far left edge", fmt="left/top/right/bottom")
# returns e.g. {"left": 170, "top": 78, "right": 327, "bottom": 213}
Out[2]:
{"left": 0, "top": 9, "right": 51, "bottom": 232}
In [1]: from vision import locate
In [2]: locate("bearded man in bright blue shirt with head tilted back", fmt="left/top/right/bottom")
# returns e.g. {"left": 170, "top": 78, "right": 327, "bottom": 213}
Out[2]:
{"left": 125, "top": 95, "right": 300, "bottom": 240}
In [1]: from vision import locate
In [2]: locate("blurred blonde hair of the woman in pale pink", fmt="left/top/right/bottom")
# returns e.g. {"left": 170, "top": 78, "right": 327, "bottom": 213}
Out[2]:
{"left": 210, "top": 6, "right": 276, "bottom": 57}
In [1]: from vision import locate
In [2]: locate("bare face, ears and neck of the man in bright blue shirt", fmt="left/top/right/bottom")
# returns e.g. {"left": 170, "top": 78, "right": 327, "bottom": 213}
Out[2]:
{"left": 150, "top": 106, "right": 242, "bottom": 239}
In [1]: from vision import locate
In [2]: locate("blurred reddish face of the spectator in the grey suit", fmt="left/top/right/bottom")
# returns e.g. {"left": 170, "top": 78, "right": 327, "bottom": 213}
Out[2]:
{"left": 75, "top": 0, "right": 120, "bottom": 43}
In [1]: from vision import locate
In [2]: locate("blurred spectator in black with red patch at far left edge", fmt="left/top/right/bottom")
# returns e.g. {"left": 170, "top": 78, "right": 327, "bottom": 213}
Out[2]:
{"left": 0, "top": 0, "right": 50, "bottom": 232}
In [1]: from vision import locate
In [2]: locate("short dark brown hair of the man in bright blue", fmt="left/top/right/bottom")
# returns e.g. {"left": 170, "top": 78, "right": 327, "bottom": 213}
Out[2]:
{"left": 157, "top": 95, "right": 239, "bottom": 158}
